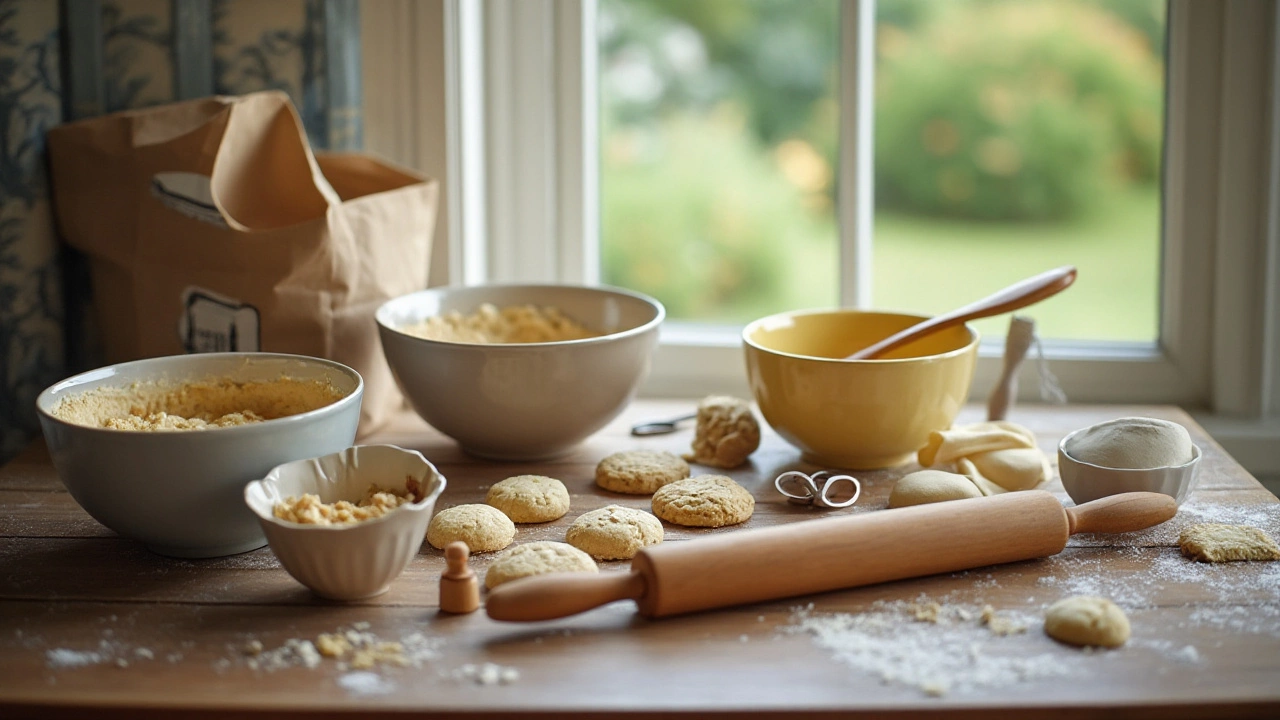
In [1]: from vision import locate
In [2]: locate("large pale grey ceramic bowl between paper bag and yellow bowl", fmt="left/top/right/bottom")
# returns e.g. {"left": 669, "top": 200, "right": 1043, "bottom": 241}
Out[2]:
{"left": 376, "top": 284, "right": 666, "bottom": 460}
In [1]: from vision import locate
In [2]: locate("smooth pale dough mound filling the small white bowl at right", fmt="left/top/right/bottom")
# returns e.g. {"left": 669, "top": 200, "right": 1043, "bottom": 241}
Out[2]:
{"left": 1065, "top": 418, "right": 1194, "bottom": 470}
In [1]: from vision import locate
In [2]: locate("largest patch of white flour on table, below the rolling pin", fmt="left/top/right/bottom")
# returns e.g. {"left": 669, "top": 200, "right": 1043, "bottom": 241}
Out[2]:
{"left": 782, "top": 598, "right": 1070, "bottom": 696}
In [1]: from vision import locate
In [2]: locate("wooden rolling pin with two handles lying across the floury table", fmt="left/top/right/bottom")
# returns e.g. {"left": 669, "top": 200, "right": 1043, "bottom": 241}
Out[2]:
{"left": 485, "top": 491, "right": 1178, "bottom": 621}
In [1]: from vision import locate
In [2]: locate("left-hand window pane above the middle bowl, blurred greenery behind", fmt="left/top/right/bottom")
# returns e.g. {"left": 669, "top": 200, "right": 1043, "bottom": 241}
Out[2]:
{"left": 599, "top": 0, "right": 838, "bottom": 322}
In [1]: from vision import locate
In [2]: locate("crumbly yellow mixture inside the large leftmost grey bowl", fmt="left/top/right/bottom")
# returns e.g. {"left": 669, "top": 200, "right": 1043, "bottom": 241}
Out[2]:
{"left": 51, "top": 377, "right": 344, "bottom": 432}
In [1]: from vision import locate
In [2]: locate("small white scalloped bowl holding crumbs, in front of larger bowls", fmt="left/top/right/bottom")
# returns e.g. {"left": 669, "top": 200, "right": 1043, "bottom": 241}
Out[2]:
{"left": 244, "top": 445, "right": 445, "bottom": 600}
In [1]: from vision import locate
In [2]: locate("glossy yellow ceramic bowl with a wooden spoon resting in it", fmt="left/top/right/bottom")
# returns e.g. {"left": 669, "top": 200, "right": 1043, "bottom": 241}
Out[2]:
{"left": 742, "top": 310, "right": 978, "bottom": 470}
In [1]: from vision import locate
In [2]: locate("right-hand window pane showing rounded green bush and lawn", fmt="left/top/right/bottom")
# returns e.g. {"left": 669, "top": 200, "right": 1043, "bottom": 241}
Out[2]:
{"left": 873, "top": 0, "right": 1166, "bottom": 341}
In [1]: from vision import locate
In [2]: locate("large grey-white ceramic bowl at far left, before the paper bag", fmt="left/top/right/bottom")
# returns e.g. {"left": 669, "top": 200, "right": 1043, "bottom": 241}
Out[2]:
{"left": 36, "top": 352, "right": 365, "bottom": 557}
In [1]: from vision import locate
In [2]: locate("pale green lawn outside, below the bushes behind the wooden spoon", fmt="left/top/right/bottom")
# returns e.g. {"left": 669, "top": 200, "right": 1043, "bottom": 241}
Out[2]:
{"left": 791, "top": 184, "right": 1160, "bottom": 342}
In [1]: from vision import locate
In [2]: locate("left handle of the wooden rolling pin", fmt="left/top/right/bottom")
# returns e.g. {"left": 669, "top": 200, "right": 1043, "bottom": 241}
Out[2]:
{"left": 485, "top": 571, "right": 648, "bottom": 623}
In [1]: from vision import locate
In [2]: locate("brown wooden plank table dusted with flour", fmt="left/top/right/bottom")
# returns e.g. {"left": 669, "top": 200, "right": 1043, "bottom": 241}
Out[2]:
{"left": 0, "top": 401, "right": 1280, "bottom": 717}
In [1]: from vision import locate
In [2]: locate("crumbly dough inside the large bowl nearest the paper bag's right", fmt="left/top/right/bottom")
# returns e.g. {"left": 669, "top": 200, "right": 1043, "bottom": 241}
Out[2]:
{"left": 399, "top": 302, "right": 600, "bottom": 343}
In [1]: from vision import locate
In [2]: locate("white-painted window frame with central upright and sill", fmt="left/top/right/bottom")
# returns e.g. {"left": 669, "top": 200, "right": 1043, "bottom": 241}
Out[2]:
{"left": 362, "top": 0, "right": 1280, "bottom": 473}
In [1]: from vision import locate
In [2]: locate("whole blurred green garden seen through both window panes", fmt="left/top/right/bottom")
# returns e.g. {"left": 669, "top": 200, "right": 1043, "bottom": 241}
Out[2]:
{"left": 600, "top": 0, "right": 1165, "bottom": 341}
